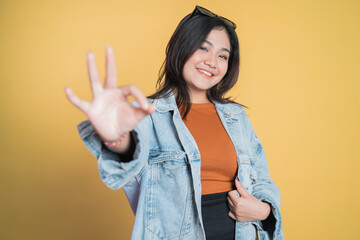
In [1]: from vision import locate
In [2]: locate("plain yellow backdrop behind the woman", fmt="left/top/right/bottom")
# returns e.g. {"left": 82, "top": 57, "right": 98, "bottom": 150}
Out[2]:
{"left": 0, "top": 0, "right": 360, "bottom": 240}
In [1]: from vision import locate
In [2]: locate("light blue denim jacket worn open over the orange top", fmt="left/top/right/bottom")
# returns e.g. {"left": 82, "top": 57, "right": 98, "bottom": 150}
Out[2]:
{"left": 78, "top": 93, "right": 283, "bottom": 240}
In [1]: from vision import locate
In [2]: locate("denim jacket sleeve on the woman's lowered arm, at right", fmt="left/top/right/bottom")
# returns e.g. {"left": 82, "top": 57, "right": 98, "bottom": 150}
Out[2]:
{"left": 243, "top": 112, "right": 284, "bottom": 240}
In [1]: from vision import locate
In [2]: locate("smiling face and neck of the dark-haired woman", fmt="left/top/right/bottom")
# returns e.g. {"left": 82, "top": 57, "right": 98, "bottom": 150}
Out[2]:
{"left": 183, "top": 29, "right": 230, "bottom": 103}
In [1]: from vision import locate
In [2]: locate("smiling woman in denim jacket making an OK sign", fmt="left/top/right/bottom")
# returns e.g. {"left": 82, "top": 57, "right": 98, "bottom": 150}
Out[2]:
{"left": 66, "top": 6, "right": 283, "bottom": 240}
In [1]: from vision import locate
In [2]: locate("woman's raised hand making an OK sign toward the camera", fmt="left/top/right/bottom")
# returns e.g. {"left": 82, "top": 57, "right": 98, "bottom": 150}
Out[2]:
{"left": 65, "top": 46, "right": 155, "bottom": 150}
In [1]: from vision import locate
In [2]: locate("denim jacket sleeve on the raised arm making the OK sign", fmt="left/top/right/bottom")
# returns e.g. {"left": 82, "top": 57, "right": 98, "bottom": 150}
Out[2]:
{"left": 77, "top": 113, "right": 150, "bottom": 190}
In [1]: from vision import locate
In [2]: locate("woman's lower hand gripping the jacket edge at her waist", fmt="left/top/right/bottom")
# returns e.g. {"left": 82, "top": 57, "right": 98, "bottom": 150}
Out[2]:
{"left": 227, "top": 179, "right": 271, "bottom": 222}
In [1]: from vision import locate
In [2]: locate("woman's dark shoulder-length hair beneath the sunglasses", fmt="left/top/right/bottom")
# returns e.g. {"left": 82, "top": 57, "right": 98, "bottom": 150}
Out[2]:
{"left": 149, "top": 11, "right": 240, "bottom": 119}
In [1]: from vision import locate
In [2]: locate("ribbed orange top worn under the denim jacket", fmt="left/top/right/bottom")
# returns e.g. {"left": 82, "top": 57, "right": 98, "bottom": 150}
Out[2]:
{"left": 184, "top": 103, "right": 237, "bottom": 195}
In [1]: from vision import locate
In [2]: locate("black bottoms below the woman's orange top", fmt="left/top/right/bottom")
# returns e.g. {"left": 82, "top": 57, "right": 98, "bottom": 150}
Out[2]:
{"left": 201, "top": 192, "right": 235, "bottom": 240}
